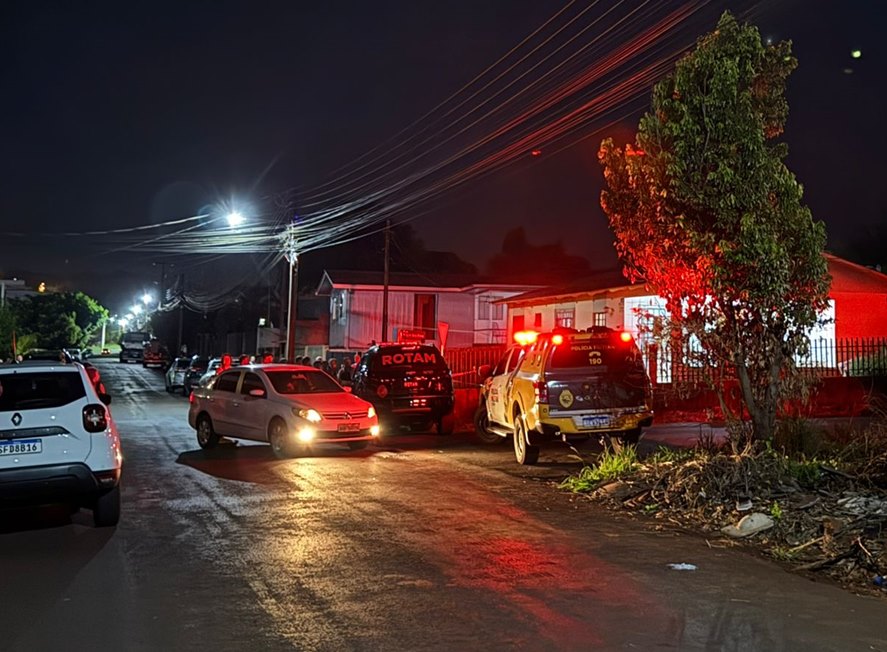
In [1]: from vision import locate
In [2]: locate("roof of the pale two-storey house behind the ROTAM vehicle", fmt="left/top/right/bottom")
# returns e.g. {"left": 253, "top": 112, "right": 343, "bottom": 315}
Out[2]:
{"left": 317, "top": 270, "right": 537, "bottom": 295}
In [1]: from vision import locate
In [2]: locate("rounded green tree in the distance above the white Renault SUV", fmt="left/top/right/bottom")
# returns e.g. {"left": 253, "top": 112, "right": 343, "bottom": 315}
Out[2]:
{"left": 11, "top": 292, "right": 109, "bottom": 349}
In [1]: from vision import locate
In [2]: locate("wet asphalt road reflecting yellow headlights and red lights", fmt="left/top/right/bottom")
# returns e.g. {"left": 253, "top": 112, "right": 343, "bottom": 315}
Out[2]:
{"left": 0, "top": 361, "right": 887, "bottom": 651}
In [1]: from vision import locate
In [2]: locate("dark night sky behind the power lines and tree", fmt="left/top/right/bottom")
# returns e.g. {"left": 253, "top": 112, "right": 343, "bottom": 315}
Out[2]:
{"left": 0, "top": 0, "right": 887, "bottom": 311}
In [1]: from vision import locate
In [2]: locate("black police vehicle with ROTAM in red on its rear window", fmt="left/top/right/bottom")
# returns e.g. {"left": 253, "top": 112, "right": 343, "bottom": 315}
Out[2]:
{"left": 352, "top": 343, "right": 455, "bottom": 435}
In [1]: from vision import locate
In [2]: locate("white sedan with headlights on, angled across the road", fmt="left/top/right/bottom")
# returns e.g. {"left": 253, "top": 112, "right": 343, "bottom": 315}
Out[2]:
{"left": 188, "top": 364, "right": 379, "bottom": 458}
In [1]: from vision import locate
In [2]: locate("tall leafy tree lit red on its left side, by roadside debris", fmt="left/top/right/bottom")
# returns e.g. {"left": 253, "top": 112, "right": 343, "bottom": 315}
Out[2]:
{"left": 599, "top": 13, "right": 830, "bottom": 438}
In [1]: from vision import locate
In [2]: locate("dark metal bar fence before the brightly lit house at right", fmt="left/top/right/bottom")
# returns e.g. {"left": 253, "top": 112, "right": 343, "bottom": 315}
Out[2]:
{"left": 643, "top": 338, "right": 887, "bottom": 384}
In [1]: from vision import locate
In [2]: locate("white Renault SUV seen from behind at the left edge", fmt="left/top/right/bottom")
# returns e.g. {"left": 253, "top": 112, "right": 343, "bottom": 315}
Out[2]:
{"left": 0, "top": 361, "right": 122, "bottom": 527}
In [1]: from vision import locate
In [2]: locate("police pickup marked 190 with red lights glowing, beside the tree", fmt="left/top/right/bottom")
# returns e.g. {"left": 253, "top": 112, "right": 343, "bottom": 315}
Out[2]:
{"left": 475, "top": 326, "right": 653, "bottom": 464}
